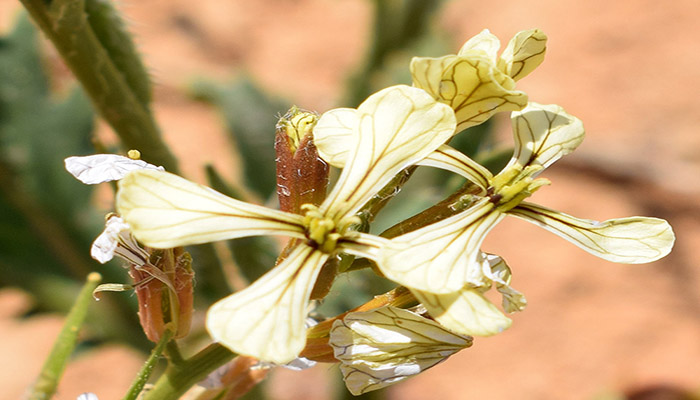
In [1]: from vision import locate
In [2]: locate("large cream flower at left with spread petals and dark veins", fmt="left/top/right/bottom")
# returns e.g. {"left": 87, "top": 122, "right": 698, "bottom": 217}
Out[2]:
{"left": 117, "top": 86, "right": 456, "bottom": 364}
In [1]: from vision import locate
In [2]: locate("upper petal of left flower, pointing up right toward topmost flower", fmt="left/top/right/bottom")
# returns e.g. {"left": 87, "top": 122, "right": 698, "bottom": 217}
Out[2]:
{"left": 318, "top": 85, "right": 455, "bottom": 218}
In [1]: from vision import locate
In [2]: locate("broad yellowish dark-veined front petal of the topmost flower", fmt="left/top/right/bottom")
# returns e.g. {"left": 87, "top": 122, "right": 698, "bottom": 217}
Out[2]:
{"left": 411, "top": 52, "right": 527, "bottom": 132}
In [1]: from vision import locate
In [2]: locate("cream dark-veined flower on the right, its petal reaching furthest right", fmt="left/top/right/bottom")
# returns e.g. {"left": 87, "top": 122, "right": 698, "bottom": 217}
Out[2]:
{"left": 377, "top": 103, "right": 675, "bottom": 335}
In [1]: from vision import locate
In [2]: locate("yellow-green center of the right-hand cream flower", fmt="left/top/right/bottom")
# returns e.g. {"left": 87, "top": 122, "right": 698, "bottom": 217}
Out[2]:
{"left": 486, "top": 164, "right": 550, "bottom": 212}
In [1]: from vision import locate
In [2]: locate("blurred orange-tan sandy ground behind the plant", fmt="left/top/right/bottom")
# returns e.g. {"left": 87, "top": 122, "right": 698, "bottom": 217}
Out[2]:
{"left": 0, "top": 0, "right": 700, "bottom": 400}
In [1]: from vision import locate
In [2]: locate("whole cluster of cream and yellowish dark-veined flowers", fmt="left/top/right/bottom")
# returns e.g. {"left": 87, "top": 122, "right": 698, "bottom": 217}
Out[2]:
{"left": 69, "top": 30, "right": 674, "bottom": 393}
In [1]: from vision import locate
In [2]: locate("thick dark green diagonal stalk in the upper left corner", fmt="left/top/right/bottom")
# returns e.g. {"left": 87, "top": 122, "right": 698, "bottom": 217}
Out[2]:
{"left": 21, "top": 0, "right": 178, "bottom": 173}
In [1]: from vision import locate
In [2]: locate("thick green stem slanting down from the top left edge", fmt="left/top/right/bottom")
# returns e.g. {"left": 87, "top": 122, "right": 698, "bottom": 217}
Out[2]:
{"left": 21, "top": 0, "right": 178, "bottom": 173}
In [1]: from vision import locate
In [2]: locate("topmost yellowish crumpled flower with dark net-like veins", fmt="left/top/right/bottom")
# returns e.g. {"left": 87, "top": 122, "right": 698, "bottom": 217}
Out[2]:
{"left": 411, "top": 29, "right": 547, "bottom": 132}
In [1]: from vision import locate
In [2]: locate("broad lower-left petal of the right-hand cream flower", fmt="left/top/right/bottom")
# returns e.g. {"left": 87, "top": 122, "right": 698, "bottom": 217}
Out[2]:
{"left": 377, "top": 198, "right": 505, "bottom": 293}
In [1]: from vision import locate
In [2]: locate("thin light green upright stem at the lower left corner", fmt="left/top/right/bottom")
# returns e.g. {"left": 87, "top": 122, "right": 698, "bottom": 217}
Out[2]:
{"left": 29, "top": 272, "right": 102, "bottom": 400}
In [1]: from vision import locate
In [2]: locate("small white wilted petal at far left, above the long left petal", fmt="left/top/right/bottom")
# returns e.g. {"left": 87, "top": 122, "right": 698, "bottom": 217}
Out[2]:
{"left": 64, "top": 154, "right": 164, "bottom": 185}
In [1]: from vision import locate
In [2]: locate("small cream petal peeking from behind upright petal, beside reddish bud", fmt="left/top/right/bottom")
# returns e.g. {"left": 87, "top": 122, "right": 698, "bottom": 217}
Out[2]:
{"left": 314, "top": 108, "right": 359, "bottom": 168}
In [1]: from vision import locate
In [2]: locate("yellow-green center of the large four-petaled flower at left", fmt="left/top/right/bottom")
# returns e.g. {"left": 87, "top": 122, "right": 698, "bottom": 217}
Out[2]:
{"left": 301, "top": 204, "right": 360, "bottom": 253}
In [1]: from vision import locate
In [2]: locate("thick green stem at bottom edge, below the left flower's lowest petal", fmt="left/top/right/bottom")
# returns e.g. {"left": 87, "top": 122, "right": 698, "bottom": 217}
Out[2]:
{"left": 143, "top": 343, "right": 236, "bottom": 400}
